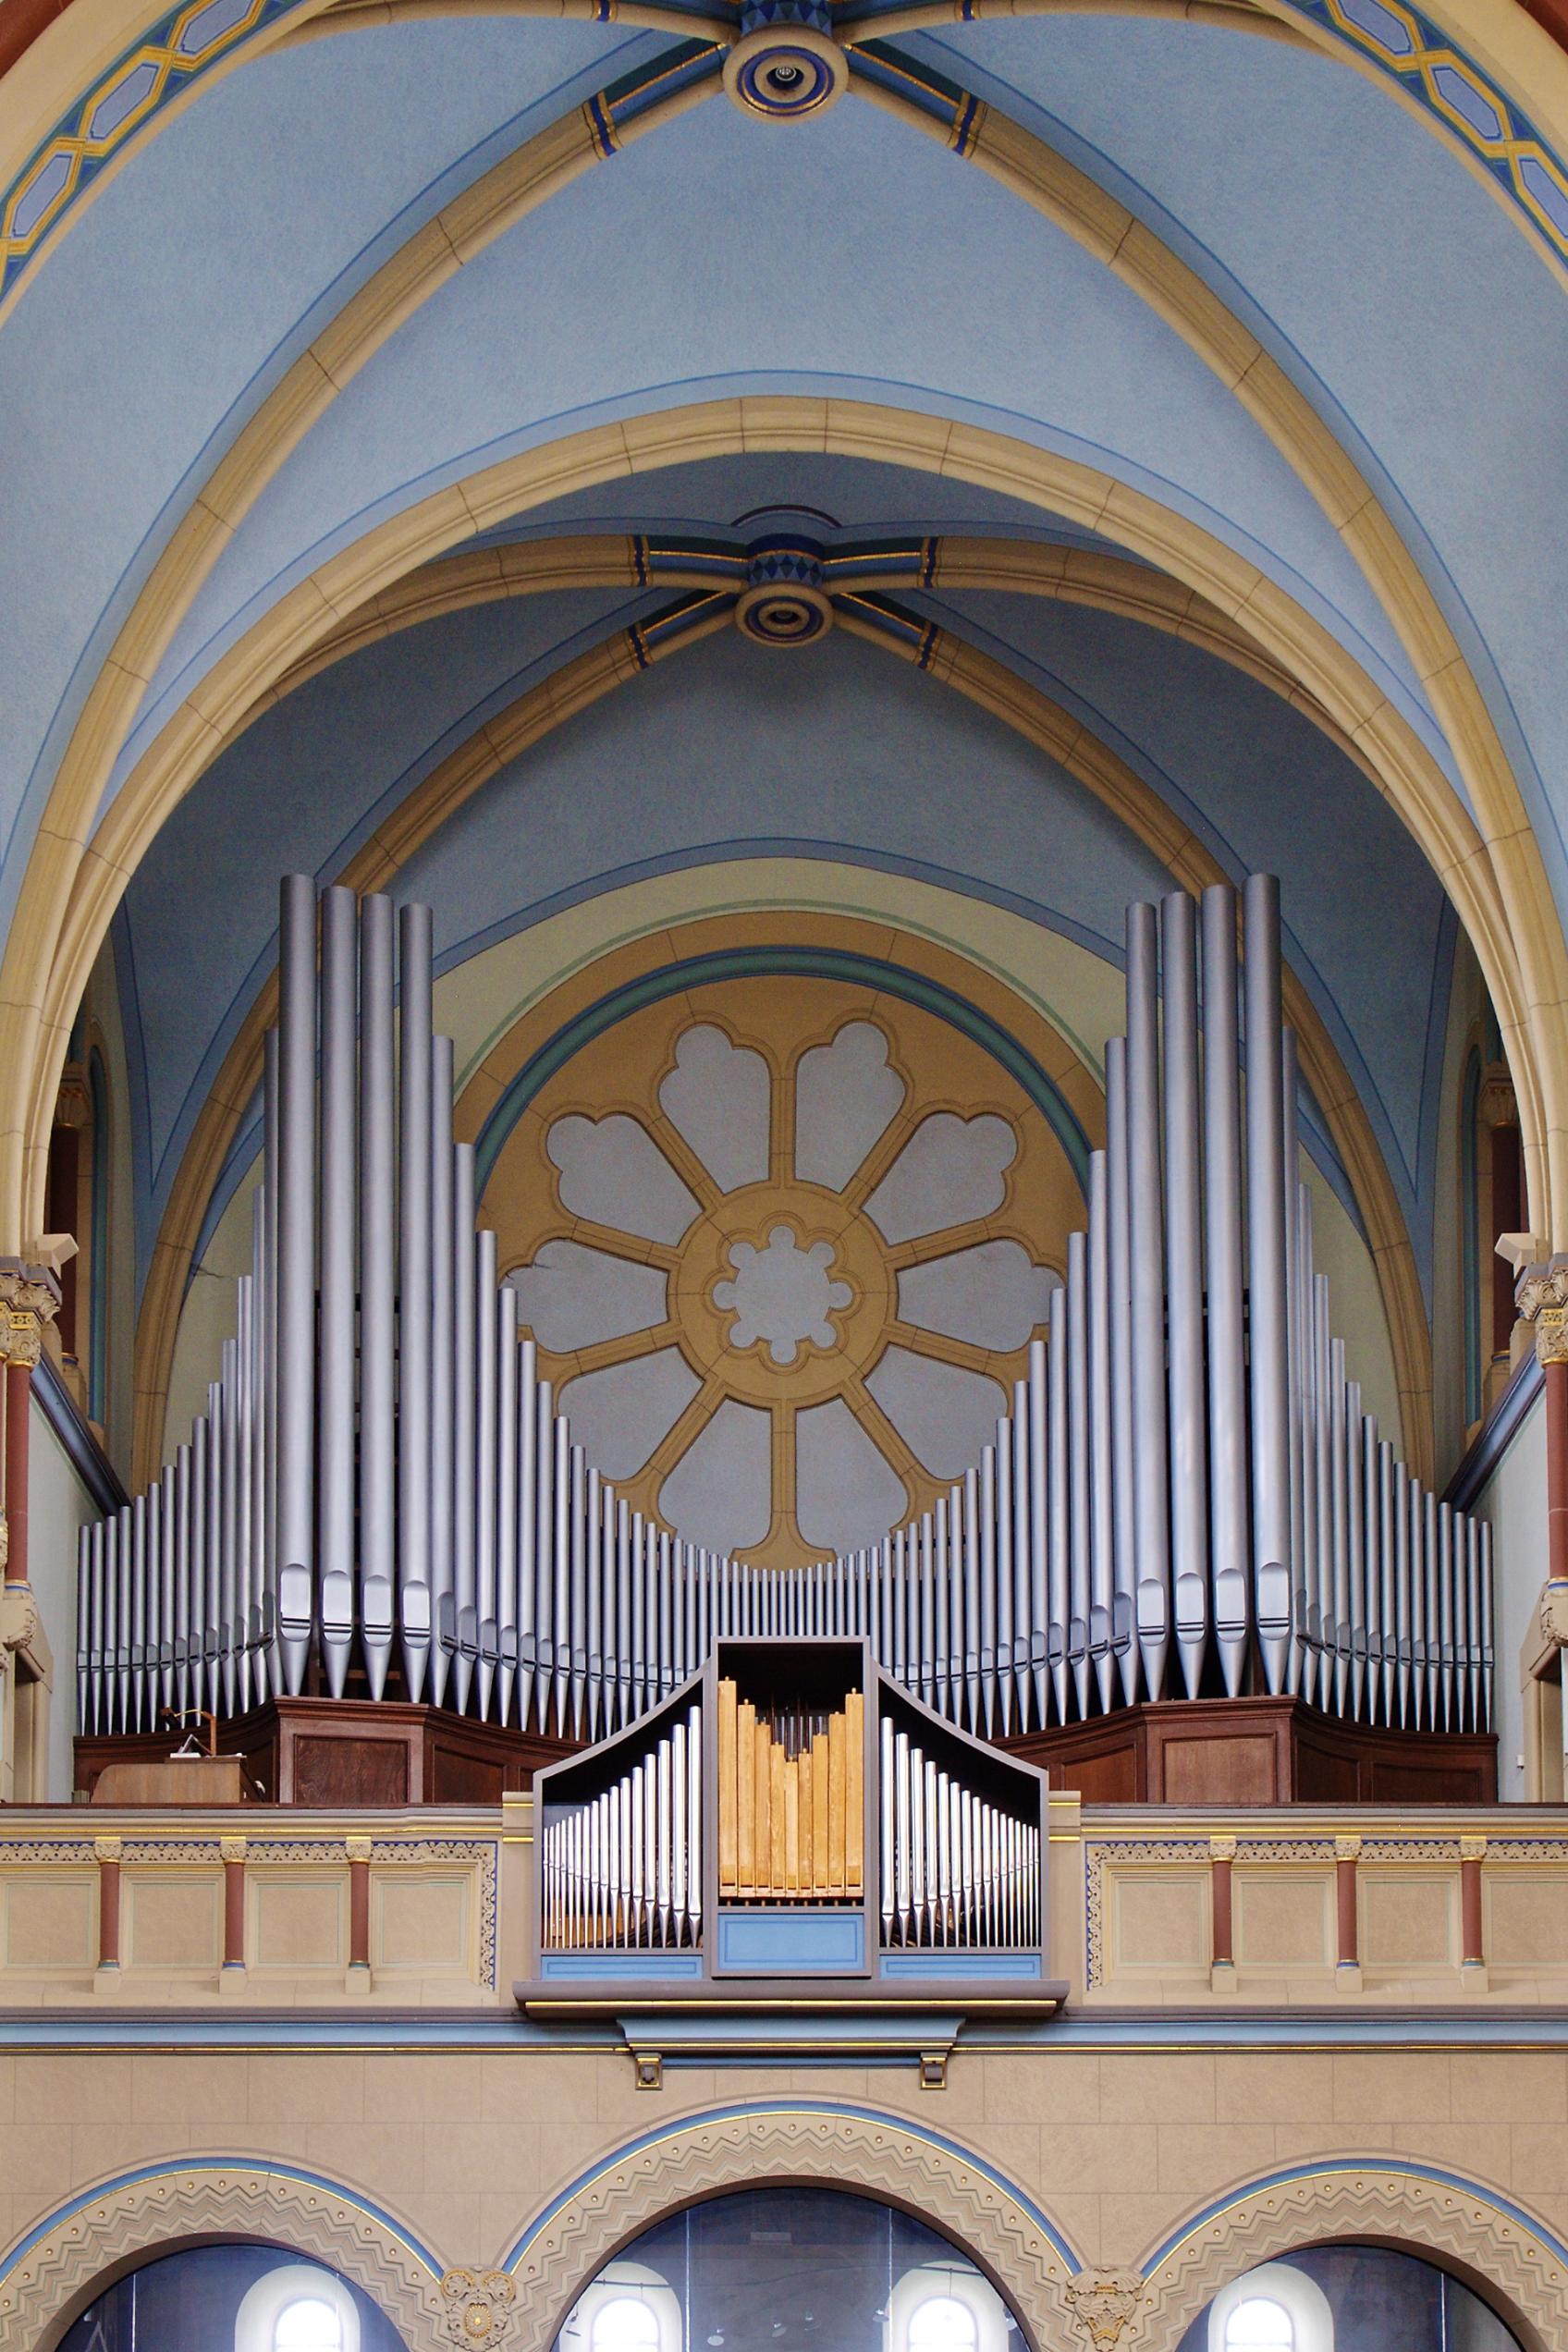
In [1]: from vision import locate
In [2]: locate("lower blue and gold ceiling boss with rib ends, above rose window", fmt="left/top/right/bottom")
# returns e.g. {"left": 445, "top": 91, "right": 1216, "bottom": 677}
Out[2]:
{"left": 625, "top": 536, "right": 940, "bottom": 670}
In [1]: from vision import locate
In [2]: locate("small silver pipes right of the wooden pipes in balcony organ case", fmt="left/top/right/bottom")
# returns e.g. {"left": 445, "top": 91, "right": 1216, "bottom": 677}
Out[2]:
{"left": 879, "top": 1715, "right": 1041, "bottom": 1953}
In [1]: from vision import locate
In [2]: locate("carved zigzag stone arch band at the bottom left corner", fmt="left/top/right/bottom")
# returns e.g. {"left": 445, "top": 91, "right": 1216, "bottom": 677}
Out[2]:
{"left": 0, "top": 2157, "right": 442, "bottom": 2352}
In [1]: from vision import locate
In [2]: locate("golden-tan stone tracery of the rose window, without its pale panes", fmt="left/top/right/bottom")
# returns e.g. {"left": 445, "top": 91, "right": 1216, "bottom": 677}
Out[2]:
{"left": 484, "top": 976, "right": 1082, "bottom": 1566}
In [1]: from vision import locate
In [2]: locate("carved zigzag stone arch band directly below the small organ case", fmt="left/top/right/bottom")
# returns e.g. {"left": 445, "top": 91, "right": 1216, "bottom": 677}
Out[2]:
{"left": 503, "top": 2101, "right": 1079, "bottom": 2352}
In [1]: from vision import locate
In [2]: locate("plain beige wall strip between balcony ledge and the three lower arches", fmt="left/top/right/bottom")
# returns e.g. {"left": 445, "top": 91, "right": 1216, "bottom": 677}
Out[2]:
{"left": 0, "top": 2049, "right": 1568, "bottom": 2317}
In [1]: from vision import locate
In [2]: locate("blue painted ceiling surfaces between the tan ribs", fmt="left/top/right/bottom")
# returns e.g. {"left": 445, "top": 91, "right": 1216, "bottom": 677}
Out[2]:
{"left": 0, "top": 7, "right": 1568, "bottom": 1373}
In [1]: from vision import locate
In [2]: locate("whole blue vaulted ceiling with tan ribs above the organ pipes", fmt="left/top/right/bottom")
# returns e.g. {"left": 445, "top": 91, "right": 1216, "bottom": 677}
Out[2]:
{"left": 0, "top": 0, "right": 1568, "bottom": 1476}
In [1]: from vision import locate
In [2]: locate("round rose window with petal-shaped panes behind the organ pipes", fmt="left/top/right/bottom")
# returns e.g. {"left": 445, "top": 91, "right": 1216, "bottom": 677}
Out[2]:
{"left": 486, "top": 978, "right": 1077, "bottom": 1566}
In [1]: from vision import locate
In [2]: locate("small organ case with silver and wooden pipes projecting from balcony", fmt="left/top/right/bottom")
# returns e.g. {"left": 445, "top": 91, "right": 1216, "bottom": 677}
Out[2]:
{"left": 517, "top": 1639, "right": 1062, "bottom": 2040}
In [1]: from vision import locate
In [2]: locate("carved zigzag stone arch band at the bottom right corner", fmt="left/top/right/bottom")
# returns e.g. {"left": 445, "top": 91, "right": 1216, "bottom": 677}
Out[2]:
{"left": 1142, "top": 2157, "right": 1568, "bottom": 2352}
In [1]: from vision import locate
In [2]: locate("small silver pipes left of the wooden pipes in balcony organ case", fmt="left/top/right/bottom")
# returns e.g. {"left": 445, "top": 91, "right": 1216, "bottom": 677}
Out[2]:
{"left": 541, "top": 1705, "right": 703, "bottom": 1953}
